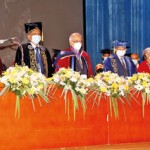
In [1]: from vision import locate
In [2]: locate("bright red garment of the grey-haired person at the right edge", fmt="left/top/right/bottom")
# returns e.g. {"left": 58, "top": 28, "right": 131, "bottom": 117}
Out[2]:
{"left": 137, "top": 60, "right": 150, "bottom": 73}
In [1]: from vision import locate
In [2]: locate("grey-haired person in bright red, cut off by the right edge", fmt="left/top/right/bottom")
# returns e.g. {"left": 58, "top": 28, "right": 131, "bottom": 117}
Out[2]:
{"left": 137, "top": 47, "right": 150, "bottom": 73}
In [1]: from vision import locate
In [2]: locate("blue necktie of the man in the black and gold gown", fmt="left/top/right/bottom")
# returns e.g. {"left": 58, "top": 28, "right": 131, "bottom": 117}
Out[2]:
{"left": 35, "top": 47, "right": 44, "bottom": 74}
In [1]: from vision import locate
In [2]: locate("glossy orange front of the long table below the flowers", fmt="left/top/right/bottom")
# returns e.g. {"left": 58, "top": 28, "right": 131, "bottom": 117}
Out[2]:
{"left": 0, "top": 89, "right": 150, "bottom": 149}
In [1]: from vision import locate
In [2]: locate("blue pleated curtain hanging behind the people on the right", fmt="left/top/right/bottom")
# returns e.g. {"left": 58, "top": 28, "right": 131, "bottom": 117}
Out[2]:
{"left": 85, "top": 0, "right": 150, "bottom": 70}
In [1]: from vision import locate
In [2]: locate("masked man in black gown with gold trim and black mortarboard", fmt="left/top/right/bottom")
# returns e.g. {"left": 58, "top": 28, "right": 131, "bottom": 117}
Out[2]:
{"left": 15, "top": 22, "right": 52, "bottom": 77}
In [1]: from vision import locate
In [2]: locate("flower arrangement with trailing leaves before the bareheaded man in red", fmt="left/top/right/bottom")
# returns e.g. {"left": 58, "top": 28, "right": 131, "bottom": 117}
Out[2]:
{"left": 48, "top": 68, "right": 88, "bottom": 119}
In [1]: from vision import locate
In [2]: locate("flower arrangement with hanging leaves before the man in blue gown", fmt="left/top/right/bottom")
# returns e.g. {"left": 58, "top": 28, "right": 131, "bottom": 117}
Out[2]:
{"left": 88, "top": 72, "right": 129, "bottom": 117}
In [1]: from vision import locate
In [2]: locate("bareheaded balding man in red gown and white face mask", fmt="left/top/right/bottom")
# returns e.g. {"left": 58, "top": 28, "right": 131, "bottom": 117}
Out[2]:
{"left": 54, "top": 33, "right": 92, "bottom": 77}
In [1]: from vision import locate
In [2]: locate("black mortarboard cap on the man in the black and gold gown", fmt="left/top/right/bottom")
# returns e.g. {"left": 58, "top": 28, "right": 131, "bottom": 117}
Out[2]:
{"left": 24, "top": 22, "right": 42, "bottom": 33}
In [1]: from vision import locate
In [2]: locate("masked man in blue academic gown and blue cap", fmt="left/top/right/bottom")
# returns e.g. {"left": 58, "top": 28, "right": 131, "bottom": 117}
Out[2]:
{"left": 104, "top": 40, "right": 136, "bottom": 77}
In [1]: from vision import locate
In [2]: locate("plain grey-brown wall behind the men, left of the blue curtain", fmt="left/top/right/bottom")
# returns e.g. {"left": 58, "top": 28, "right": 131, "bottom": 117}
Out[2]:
{"left": 0, "top": 0, "right": 83, "bottom": 67}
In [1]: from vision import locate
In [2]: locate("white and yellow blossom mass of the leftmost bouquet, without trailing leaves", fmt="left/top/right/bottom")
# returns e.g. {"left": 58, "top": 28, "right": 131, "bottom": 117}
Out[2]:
{"left": 0, "top": 66, "right": 47, "bottom": 97}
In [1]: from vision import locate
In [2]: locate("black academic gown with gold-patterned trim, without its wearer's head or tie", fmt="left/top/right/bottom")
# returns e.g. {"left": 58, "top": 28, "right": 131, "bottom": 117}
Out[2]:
{"left": 15, "top": 43, "right": 52, "bottom": 77}
